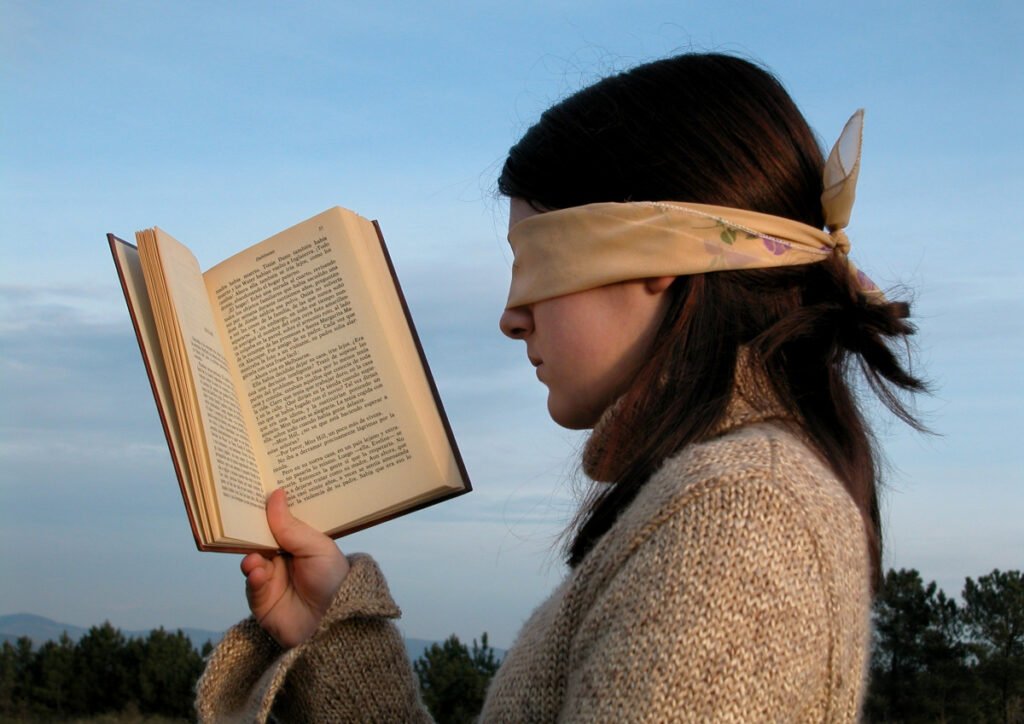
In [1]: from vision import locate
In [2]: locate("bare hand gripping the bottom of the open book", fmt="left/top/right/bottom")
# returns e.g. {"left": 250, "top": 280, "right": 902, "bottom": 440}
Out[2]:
{"left": 242, "top": 488, "right": 348, "bottom": 648}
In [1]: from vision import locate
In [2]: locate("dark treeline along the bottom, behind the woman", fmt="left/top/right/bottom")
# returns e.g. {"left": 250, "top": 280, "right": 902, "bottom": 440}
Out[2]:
{"left": 0, "top": 569, "right": 1024, "bottom": 723}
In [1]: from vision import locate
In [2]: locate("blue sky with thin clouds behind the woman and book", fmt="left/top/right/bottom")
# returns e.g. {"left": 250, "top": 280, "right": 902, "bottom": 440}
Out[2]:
{"left": 0, "top": 0, "right": 1024, "bottom": 647}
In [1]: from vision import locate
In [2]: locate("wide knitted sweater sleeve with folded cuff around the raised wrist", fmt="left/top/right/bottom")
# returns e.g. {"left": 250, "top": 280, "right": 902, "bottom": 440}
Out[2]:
{"left": 196, "top": 554, "right": 430, "bottom": 722}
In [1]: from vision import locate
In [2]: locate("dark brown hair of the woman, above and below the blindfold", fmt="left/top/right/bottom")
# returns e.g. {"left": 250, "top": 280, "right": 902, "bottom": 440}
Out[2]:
{"left": 498, "top": 54, "right": 925, "bottom": 589}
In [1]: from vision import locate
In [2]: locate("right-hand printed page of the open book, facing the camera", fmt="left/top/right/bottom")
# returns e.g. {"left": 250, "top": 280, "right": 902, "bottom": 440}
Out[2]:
{"left": 205, "top": 209, "right": 454, "bottom": 530}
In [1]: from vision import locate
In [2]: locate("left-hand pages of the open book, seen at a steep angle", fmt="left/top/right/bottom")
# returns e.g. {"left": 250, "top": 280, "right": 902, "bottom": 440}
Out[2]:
{"left": 139, "top": 229, "right": 276, "bottom": 548}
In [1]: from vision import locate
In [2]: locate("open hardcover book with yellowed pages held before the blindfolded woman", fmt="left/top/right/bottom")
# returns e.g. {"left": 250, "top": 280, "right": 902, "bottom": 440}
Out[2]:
{"left": 108, "top": 207, "right": 470, "bottom": 551}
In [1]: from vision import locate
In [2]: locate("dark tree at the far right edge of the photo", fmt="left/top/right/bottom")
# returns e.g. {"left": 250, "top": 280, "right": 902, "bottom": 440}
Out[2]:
{"left": 964, "top": 569, "right": 1024, "bottom": 722}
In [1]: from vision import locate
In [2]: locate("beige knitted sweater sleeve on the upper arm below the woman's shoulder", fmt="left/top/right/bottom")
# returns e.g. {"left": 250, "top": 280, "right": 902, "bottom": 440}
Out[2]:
{"left": 561, "top": 471, "right": 861, "bottom": 722}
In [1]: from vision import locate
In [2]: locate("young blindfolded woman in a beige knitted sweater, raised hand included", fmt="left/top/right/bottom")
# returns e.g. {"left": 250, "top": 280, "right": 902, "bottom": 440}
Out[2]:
{"left": 198, "top": 54, "right": 923, "bottom": 722}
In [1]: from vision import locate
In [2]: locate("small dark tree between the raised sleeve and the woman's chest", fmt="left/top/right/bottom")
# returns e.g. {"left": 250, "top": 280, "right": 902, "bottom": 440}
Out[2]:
{"left": 413, "top": 633, "right": 499, "bottom": 724}
